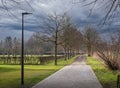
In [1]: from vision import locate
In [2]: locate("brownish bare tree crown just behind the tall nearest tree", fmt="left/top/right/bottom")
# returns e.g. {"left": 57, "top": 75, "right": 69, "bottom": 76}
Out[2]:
{"left": 61, "top": 24, "right": 82, "bottom": 60}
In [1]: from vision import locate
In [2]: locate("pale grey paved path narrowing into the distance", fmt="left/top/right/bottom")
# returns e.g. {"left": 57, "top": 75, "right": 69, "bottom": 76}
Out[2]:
{"left": 33, "top": 56, "right": 102, "bottom": 88}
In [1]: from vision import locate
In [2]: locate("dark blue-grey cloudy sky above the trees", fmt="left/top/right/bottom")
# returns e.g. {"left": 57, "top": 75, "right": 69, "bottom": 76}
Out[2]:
{"left": 0, "top": 0, "right": 120, "bottom": 39}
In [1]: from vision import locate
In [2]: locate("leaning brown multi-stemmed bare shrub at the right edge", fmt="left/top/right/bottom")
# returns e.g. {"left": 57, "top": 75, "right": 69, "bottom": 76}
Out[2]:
{"left": 96, "top": 28, "right": 120, "bottom": 70}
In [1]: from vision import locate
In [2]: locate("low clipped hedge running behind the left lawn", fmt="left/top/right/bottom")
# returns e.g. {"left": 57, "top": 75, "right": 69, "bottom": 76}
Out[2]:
{"left": 0, "top": 55, "right": 64, "bottom": 64}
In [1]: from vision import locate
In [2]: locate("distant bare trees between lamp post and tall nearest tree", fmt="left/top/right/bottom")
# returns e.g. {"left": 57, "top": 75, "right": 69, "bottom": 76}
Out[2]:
{"left": 25, "top": 32, "right": 53, "bottom": 55}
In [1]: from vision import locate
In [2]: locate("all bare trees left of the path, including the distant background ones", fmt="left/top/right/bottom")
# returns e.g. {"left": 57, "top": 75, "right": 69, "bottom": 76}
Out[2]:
{"left": 0, "top": 13, "right": 83, "bottom": 65}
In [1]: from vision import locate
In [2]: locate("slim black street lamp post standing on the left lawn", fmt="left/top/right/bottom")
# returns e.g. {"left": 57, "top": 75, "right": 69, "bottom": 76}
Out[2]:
{"left": 21, "top": 12, "right": 32, "bottom": 88}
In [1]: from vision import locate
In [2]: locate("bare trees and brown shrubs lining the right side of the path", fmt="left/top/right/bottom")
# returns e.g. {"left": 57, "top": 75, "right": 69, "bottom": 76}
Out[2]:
{"left": 83, "top": 26, "right": 120, "bottom": 70}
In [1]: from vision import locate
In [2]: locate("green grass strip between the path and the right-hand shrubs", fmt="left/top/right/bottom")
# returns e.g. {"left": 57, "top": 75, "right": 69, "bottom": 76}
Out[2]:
{"left": 87, "top": 57, "right": 117, "bottom": 88}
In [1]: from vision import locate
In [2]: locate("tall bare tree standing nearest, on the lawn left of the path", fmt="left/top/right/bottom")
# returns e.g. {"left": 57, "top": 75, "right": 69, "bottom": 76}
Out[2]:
{"left": 40, "top": 13, "right": 71, "bottom": 65}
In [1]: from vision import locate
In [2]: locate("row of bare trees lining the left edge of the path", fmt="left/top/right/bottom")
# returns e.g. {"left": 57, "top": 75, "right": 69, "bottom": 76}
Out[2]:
{"left": 27, "top": 13, "right": 83, "bottom": 65}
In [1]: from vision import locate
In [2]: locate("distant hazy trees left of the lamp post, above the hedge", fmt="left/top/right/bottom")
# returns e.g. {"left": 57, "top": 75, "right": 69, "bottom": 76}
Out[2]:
{"left": 0, "top": 36, "right": 20, "bottom": 57}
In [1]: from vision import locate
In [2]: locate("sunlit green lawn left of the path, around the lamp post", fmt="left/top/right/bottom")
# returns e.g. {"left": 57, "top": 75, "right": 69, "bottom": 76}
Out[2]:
{"left": 0, "top": 56, "right": 78, "bottom": 88}
